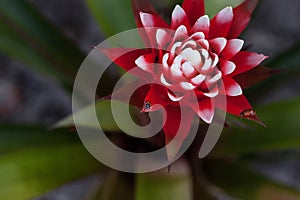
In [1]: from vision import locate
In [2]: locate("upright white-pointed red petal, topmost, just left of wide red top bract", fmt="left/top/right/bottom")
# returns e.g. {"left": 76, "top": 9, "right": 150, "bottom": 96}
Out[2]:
{"left": 171, "top": 5, "right": 190, "bottom": 30}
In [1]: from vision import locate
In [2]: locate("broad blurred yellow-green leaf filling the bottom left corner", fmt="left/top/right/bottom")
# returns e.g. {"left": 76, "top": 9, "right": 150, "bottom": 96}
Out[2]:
{"left": 0, "top": 126, "right": 103, "bottom": 200}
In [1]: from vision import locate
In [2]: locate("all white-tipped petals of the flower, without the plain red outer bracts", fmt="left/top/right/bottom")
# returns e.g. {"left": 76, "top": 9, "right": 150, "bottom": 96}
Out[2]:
{"left": 131, "top": 5, "right": 250, "bottom": 123}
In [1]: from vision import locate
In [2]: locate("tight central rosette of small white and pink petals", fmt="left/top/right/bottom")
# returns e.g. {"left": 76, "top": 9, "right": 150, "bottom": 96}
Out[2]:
{"left": 160, "top": 27, "right": 222, "bottom": 97}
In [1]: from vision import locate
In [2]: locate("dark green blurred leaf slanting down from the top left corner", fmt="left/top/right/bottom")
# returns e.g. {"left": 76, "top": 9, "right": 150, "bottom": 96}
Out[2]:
{"left": 0, "top": 0, "right": 84, "bottom": 84}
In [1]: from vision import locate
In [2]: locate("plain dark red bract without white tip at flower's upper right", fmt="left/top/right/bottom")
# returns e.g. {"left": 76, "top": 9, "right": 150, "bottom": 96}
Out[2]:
{"left": 228, "top": 0, "right": 258, "bottom": 39}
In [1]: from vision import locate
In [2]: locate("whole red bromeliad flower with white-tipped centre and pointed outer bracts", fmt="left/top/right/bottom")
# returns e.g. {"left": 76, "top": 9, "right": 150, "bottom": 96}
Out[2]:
{"left": 101, "top": 0, "right": 267, "bottom": 159}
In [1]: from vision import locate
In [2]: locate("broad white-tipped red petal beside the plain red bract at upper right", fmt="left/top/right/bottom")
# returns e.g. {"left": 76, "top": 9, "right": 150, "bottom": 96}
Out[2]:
{"left": 209, "top": 7, "right": 233, "bottom": 39}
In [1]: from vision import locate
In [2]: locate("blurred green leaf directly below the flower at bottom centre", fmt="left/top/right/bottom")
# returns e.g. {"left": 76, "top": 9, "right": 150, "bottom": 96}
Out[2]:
{"left": 135, "top": 162, "right": 192, "bottom": 200}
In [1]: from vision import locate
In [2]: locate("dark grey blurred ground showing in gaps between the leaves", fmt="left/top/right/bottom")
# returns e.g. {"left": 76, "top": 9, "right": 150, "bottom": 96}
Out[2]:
{"left": 0, "top": 0, "right": 300, "bottom": 200}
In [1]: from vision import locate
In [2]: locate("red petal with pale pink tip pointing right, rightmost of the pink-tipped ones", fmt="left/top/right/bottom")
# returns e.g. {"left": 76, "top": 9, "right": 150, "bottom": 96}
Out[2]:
{"left": 230, "top": 51, "right": 268, "bottom": 77}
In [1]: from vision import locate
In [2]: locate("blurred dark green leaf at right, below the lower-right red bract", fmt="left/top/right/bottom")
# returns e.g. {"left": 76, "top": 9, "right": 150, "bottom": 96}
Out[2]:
{"left": 212, "top": 99, "right": 300, "bottom": 156}
